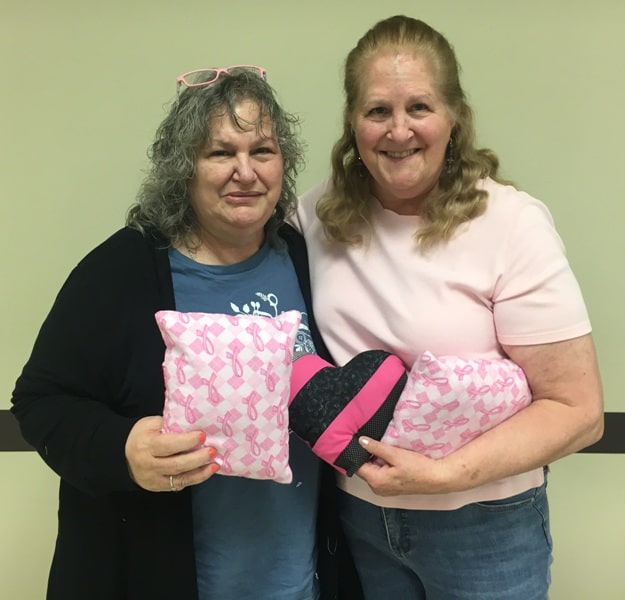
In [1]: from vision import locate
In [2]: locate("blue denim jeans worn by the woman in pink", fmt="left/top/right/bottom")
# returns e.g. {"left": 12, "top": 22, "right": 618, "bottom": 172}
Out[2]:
{"left": 340, "top": 482, "right": 552, "bottom": 600}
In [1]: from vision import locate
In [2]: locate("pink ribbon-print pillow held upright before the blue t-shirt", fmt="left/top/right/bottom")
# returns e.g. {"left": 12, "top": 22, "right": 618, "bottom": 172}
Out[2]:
{"left": 155, "top": 310, "right": 301, "bottom": 483}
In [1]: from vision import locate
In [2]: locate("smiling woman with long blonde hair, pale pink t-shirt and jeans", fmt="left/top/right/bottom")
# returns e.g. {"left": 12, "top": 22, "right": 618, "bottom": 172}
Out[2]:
{"left": 294, "top": 15, "right": 603, "bottom": 600}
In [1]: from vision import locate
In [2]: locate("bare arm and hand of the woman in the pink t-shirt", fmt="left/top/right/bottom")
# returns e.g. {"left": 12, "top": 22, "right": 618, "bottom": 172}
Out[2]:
{"left": 358, "top": 335, "right": 603, "bottom": 496}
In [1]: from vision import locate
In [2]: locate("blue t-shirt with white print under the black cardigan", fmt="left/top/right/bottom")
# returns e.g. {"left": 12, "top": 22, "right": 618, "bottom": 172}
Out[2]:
{"left": 169, "top": 243, "right": 320, "bottom": 600}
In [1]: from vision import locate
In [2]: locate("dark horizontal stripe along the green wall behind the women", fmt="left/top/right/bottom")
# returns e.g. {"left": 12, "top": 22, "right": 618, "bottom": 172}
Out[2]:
{"left": 0, "top": 410, "right": 625, "bottom": 454}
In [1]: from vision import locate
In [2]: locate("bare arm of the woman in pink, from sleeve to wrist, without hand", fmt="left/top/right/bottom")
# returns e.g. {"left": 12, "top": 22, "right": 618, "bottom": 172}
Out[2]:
{"left": 434, "top": 335, "right": 603, "bottom": 491}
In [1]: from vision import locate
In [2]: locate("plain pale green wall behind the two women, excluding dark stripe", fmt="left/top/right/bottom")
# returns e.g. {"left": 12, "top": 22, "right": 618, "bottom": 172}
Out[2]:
{"left": 0, "top": 0, "right": 625, "bottom": 600}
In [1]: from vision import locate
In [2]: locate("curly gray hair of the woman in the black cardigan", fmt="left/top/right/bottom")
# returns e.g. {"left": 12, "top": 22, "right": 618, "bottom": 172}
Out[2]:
{"left": 126, "top": 69, "right": 304, "bottom": 246}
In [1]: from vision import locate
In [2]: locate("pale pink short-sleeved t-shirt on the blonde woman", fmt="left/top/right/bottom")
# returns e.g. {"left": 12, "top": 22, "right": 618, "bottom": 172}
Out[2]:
{"left": 292, "top": 179, "right": 591, "bottom": 510}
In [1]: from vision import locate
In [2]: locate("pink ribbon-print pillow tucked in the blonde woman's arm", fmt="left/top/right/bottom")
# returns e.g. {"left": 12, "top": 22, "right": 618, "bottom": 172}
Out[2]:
{"left": 382, "top": 352, "right": 532, "bottom": 458}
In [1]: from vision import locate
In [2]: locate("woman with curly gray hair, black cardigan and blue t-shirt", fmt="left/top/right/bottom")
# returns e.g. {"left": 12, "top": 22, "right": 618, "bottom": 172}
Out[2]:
{"left": 12, "top": 66, "right": 355, "bottom": 600}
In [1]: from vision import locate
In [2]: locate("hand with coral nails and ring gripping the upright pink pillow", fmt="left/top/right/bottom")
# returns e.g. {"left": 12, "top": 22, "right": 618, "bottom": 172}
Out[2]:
{"left": 125, "top": 416, "right": 219, "bottom": 492}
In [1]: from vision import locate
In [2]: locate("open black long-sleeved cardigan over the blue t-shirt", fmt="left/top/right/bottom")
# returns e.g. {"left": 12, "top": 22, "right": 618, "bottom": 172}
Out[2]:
{"left": 12, "top": 226, "right": 359, "bottom": 600}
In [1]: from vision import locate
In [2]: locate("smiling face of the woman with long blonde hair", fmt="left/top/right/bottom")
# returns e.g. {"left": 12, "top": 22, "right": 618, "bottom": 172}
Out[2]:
{"left": 352, "top": 52, "right": 453, "bottom": 214}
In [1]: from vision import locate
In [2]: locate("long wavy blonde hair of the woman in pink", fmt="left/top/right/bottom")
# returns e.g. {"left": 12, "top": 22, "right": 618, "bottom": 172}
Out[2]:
{"left": 317, "top": 15, "right": 508, "bottom": 249}
